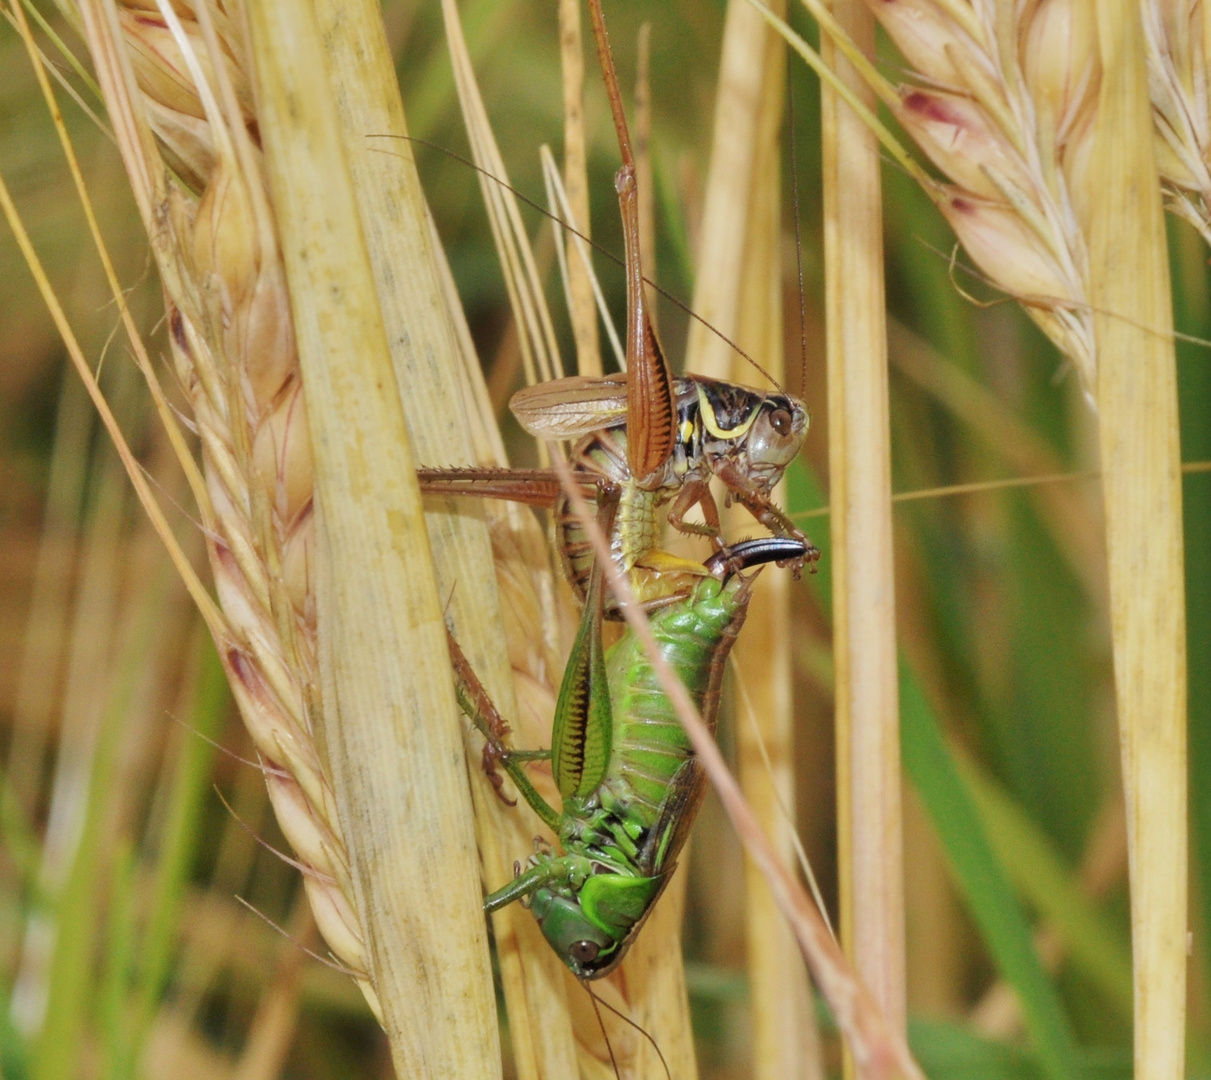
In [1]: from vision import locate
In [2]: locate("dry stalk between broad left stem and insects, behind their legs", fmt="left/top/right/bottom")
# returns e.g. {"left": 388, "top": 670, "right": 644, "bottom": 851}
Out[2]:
{"left": 317, "top": 0, "right": 585, "bottom": 1078}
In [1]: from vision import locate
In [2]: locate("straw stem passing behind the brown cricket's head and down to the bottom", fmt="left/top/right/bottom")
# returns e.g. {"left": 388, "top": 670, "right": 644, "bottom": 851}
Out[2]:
{"left": 687, "top": 2, "right": 822, "bottom": 1080}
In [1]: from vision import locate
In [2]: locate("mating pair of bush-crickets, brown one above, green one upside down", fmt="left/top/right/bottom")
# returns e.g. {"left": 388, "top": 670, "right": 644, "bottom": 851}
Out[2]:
{"left": 419, "top": 0, "right": 819, "bottom": 978}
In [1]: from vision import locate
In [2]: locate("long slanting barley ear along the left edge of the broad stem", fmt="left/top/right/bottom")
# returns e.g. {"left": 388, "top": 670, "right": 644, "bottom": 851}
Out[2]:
{"left": 70, "top": 2, "right": 378, "bottom": 1007}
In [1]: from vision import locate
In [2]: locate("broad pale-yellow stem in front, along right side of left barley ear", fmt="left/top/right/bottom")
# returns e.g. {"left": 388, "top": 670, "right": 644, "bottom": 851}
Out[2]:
{"left": 248, "top": 2, "right": 500, "bottom": 1078}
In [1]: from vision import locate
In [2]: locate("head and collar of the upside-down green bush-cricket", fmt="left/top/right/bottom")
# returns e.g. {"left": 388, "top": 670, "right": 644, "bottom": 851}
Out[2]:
{"left": 530, "top": 873, "right": 668, "bottom": 978}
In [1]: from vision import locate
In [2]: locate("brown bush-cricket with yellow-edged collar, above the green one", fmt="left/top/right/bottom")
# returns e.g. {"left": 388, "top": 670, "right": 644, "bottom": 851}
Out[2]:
{"left": 418, "top": 0, "right": 820, "bottom": 616}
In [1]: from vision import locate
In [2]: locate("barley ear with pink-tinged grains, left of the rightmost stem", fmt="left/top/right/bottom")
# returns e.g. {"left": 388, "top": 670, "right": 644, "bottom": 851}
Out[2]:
{"left": 852, "top": 0, "right": 1098, "bottom": 392}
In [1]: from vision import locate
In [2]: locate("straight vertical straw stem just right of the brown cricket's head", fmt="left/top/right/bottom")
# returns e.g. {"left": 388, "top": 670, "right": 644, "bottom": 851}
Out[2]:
{"left": 822, "top": 0, "right": 906, "bottom": 1050}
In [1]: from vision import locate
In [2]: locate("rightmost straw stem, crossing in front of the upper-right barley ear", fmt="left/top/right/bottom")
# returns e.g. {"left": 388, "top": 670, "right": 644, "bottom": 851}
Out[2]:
{"left": 1090, "top": 0, "right": 1187, "bottom": 1080}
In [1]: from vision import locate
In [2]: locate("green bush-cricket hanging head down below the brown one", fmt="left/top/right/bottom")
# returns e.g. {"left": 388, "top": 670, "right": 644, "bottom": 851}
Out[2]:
{"left": 449, "top": 523, "right": 807, "bottom": 978}
